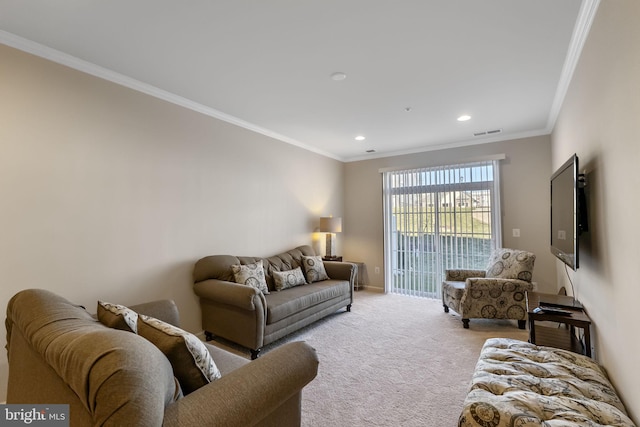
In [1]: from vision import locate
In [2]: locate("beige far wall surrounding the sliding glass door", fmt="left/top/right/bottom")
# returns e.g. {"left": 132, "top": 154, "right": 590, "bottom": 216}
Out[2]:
{"left": 344, "top": 136, "right": 556, "bottom": 292}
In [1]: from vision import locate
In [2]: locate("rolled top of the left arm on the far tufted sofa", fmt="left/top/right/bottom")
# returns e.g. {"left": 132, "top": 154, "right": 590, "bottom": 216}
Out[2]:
{"left": 193, "top": 279, "right": 267, "bottom": 311}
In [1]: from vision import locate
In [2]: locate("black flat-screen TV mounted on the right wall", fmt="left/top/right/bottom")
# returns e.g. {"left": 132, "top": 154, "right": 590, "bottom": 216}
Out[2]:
{"left": 551, "top": 154, "right": 588, "bottom": 270}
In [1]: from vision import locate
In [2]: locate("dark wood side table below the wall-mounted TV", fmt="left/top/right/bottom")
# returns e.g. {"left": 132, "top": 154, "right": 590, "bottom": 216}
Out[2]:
{"left": 527, "top": 292, "right": 591, "bottom": 357}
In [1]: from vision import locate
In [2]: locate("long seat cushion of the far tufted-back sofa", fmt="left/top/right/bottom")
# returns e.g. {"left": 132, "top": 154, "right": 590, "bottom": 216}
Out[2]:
{"left": 266, "top": 280, "right": 351, "bottom": 324}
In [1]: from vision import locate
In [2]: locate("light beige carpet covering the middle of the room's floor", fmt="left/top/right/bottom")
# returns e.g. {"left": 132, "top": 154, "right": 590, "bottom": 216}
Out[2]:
{"left": 215, "top": 290, "right": 528, "bottom": 427}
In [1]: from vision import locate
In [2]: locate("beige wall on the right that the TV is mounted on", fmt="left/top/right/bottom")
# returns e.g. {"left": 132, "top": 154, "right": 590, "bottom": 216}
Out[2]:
{"left": 552, "top": 0, "right": 640, "bottom": 423}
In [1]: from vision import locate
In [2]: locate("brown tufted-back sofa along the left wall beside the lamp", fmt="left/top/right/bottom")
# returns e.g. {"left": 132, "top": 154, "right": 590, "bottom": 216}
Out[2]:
{"left": 193, "top": 246, "right": 356, "bottom": 359}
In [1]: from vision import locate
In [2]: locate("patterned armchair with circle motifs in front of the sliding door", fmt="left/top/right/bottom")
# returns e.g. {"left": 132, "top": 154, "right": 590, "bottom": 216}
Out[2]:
{"left": 442, "top": 248, "right": 536, "bottom": 329}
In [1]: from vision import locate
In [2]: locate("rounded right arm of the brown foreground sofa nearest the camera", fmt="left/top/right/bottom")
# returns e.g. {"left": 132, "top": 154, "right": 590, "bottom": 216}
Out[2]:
{"left": 163, "top": 341, "right": 318, "bottom": 427}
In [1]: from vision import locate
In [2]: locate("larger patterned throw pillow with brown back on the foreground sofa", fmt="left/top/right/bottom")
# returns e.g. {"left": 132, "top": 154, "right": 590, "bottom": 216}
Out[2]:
{"left": 138, "top": 314, "right": 222, "bottom": 395}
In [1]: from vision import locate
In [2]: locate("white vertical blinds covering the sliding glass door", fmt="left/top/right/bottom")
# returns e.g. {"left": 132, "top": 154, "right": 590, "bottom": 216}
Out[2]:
{"left": 382, "top": 157, "right": 503, "bottom": 298}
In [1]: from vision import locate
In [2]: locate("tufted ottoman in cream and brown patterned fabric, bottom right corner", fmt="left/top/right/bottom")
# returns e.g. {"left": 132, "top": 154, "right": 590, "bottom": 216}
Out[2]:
{"left": 458, "top": 338, "right": 635, "bottom": 427}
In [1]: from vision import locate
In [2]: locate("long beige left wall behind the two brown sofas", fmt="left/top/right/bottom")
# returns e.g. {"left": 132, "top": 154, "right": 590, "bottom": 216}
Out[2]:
{"left": 0, "top": 45, "right": 344, "bottom": 401}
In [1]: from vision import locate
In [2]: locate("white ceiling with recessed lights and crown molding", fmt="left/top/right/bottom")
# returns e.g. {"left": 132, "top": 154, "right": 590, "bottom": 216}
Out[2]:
{"left": 0, "top": 0, "right": 598, "bottom": 161}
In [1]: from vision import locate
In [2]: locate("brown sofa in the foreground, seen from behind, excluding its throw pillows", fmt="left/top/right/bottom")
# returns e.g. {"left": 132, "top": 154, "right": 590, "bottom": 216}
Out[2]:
{"left": 5, "top": 289, "right": 318, "bottom": 427}
